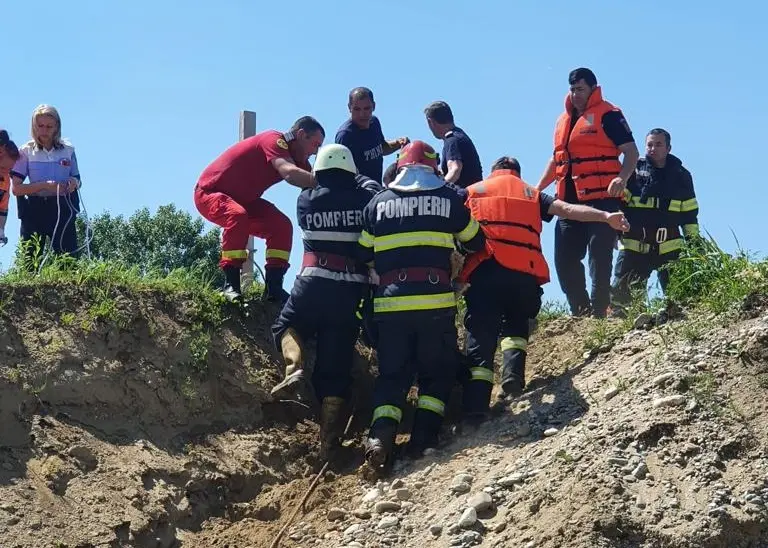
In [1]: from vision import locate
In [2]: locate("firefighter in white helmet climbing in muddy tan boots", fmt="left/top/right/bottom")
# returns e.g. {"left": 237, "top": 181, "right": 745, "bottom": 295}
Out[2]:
{"left": 272, "top": 144, "right": 380, "bottom": 458}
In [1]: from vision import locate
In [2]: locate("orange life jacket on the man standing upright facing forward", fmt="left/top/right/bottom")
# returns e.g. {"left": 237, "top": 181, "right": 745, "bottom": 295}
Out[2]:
{"left": 555, "top": 86, "right": 621, "bottom": 202}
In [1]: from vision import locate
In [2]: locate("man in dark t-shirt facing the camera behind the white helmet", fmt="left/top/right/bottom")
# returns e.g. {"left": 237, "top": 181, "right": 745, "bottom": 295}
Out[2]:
{"left": 335, "top": 88, "right": 409, "bottom": 183}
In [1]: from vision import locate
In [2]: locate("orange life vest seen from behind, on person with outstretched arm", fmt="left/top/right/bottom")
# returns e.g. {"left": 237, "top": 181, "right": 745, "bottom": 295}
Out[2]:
{"left": 458, "top": 169, "right": 549, "bottom": 285}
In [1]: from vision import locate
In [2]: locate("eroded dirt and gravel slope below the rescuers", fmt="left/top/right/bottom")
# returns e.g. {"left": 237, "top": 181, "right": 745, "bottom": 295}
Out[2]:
{"left": 0, "top": 287, "right": 768, "bottom": 548}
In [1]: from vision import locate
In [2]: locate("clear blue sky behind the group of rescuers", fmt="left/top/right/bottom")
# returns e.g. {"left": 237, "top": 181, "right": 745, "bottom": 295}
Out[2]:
{"left": 0, "top": 0, "right": 768, "bottom": 299}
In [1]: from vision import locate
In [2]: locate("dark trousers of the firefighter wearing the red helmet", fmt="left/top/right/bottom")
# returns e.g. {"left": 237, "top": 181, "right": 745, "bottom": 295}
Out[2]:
{"left": 371, "top": 311, "right": 458, "bottom": 447}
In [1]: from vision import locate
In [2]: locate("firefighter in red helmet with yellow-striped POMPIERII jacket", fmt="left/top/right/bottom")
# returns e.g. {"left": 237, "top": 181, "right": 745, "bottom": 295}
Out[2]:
{"left": 359, "top": 141, "right": 484, "bottom": 468}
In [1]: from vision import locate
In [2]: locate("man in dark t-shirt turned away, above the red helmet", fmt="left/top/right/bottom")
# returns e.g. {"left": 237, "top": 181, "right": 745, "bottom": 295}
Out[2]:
{"left": 424, "top": 101, "right": 483, "bottom": 188}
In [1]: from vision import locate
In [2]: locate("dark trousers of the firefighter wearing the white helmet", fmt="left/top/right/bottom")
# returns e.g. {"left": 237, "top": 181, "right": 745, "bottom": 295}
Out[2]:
{"left": 272, "top": 276, "right": 368, "bottom": 401}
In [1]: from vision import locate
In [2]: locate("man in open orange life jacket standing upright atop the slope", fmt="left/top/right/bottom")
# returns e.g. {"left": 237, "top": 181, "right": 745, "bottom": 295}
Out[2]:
{"left": 536, "top": 68, "right": 639, "bottom": 318}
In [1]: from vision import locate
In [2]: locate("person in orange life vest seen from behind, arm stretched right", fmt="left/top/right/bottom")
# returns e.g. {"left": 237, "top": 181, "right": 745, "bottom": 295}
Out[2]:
{"left": 458, "top": 157, "right": 629, "bottom": 421}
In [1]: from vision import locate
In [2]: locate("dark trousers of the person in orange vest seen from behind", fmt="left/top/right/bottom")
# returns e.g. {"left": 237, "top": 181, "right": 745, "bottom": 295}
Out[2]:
{"left": 464, "top": 258, "right": 543, "bottom": 414}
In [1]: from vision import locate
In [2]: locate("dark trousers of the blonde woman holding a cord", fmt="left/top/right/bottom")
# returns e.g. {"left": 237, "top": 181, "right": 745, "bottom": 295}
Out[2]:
{"left": 17, "top": 194, "right": 80, "bottom": 255}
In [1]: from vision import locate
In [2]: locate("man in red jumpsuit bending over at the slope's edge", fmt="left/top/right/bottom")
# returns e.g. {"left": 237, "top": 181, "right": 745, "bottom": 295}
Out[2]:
{"left": 195, "top": 116, "right": 325, "bottom": 303}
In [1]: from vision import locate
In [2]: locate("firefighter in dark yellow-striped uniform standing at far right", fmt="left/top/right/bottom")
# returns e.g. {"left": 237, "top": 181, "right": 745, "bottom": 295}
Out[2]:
{"left": 611, "top": 128, "right": 699, "bottom": 317}
